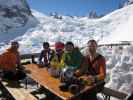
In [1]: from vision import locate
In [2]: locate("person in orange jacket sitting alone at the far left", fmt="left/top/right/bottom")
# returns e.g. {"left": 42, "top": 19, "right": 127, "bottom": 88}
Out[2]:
{"left": 0, "top": 42, "right": 26, "bottom": 81}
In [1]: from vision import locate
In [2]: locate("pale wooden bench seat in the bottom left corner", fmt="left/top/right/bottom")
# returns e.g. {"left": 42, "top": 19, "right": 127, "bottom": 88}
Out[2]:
{"left": 1, "top": 81, "right": 37, "bottom": 100}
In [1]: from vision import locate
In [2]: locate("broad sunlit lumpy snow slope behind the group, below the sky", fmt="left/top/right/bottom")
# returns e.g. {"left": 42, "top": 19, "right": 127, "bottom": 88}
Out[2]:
{"left": 14, "top": 5, "right": 133, "bottom": 52}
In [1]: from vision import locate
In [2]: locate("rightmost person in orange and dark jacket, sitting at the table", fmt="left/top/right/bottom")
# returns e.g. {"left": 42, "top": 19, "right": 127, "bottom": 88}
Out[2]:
{"left": 75, "top": 40, "right": 106, "bottom": 100}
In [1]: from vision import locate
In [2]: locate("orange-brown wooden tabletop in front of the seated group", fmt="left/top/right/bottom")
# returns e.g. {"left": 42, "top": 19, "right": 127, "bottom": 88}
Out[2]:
{"left": 25, "top": 64, "right": 92, "bottom": 100}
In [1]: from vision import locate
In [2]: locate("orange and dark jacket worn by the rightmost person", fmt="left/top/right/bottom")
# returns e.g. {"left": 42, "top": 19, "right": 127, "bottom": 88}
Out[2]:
{"left": 80, "top": 54, "right": 106, "bottom": 80}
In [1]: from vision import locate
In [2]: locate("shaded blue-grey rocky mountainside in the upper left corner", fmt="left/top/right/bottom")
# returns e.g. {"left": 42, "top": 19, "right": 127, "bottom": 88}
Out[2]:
{"left": 0, "top": 0, "right": 37, "bottom": 42}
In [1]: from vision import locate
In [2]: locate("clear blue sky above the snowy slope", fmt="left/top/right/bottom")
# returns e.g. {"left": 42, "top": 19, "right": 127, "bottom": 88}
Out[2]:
{"left": 27, "top": 0, "right": 120, "bottom": 16}
